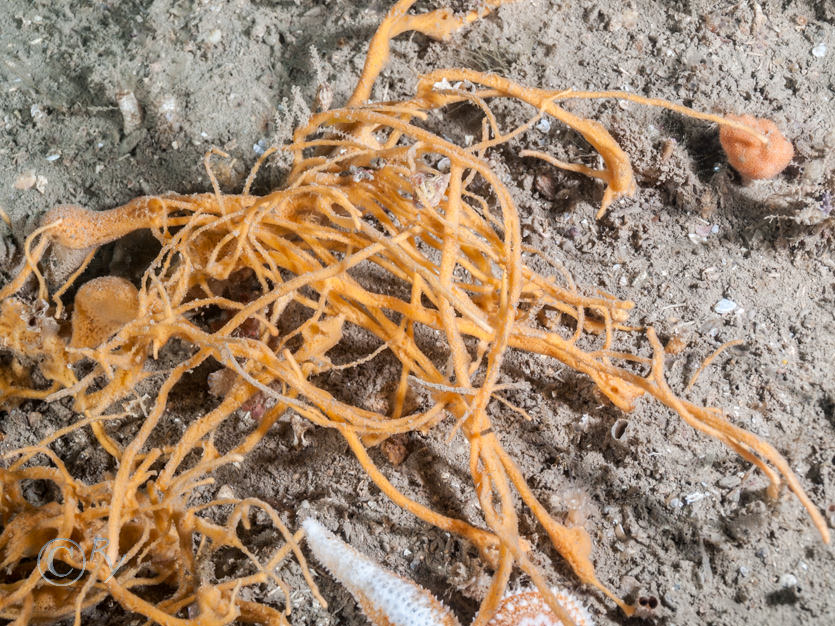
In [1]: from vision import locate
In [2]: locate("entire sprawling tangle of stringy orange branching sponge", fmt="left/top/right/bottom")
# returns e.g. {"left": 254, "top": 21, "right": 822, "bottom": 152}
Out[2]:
{"left": 0, "top": 0, "right": 829, "bottom": 625}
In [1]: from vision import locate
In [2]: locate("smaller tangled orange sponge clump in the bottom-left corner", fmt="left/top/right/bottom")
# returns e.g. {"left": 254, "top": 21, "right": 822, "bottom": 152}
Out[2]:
{"left": 0, "top": 444, "right": 318, "bottom": 626}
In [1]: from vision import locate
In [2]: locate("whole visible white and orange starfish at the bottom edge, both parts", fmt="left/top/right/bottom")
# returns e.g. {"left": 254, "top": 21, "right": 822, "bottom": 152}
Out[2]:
{"left": 302, "top": 519, "right": 593, "bottom": 626}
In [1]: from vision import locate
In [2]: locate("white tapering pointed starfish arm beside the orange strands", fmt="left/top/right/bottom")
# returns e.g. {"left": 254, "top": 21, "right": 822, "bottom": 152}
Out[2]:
{"left": 302, "top": 519, "right": 460, "bottom": 626}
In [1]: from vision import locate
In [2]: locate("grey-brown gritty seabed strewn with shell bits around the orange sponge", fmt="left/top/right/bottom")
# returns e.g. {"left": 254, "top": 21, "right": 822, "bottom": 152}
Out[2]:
{"left": 0, "top": 0, "right": 835, "bottom": 626}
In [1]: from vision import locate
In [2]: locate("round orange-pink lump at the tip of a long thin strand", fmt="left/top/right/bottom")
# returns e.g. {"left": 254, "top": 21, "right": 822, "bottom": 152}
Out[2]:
{"left": 719, "top": 115, "right": 794, "bottom": 180}
